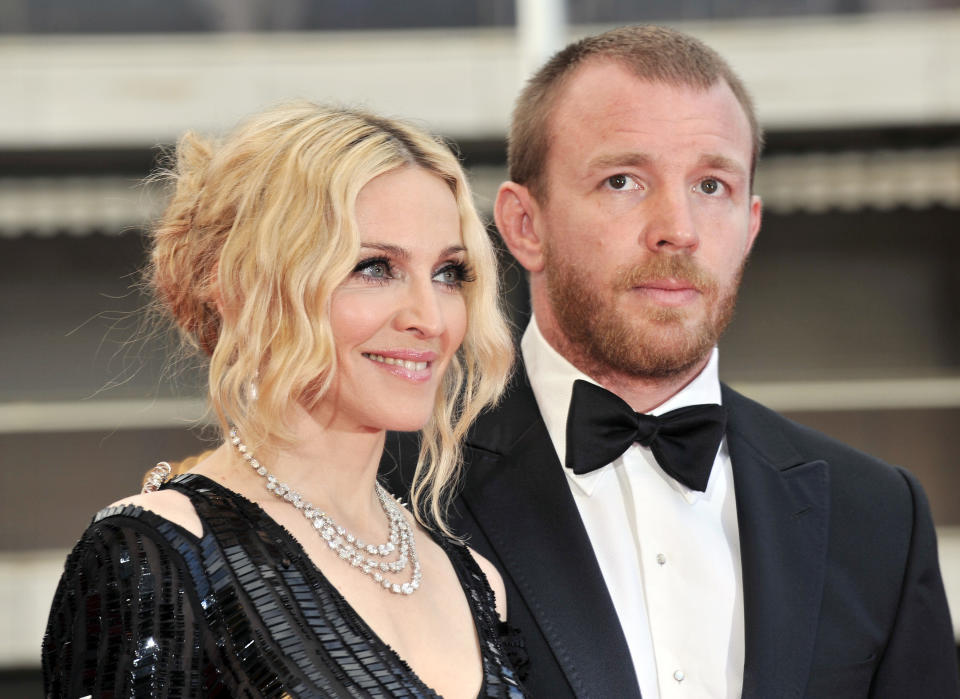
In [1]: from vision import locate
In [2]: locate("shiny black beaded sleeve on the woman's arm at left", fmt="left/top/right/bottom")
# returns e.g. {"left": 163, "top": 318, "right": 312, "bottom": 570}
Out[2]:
{"left": 42, "top": 508, "right": 209, "bottom": 697}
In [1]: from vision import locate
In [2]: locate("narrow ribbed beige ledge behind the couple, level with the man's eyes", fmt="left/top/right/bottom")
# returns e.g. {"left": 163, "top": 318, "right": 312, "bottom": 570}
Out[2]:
{"left": 0, "top": 148, "right": 960, "bottom": 237}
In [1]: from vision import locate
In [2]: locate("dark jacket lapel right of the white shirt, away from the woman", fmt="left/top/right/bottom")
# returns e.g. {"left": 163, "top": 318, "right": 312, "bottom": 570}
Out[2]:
{"left": 723, "top": 387, "right": 830, "bottom": 699}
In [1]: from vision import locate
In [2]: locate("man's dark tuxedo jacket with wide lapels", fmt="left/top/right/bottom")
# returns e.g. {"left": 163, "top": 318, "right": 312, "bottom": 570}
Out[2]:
{"left": 381, "top": 369, "right": 960, "bottom": 699}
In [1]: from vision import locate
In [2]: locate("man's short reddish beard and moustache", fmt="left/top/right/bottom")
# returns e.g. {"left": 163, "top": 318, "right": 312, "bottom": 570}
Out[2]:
{"left": 545, "top": 246, "right": 746, "bottom": 379}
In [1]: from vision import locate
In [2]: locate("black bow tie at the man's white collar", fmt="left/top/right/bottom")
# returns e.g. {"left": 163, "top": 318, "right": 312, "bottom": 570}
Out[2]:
{"left": 566, "top": 379, "right": 727, "bottom": 492}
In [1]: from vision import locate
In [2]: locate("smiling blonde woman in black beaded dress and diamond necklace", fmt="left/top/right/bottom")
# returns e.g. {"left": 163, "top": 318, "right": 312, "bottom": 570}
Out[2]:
{"left": 43, "top": 103, "right": 522, "bottom": 697}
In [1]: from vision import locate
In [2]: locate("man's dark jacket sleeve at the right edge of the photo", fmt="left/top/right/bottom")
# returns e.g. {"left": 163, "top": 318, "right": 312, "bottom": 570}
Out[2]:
{"left": 870, "top": 470, "right": 960, "bottom": 699}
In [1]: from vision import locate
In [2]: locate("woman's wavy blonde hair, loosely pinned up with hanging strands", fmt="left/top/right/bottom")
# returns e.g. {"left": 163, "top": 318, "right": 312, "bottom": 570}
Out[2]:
{"left": 146, "top": 102, "right": 513, "bottom": 533}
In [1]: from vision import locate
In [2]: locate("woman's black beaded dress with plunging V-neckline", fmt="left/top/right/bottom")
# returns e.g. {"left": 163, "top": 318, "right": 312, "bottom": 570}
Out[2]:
{"left": 43, "top": 474, "right": 523, "bottom": 698}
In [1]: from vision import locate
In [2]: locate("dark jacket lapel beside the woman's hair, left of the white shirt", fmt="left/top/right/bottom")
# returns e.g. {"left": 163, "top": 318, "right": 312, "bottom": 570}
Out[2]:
{"left": 462, "top": 387, "right": 640, "bottom": 697}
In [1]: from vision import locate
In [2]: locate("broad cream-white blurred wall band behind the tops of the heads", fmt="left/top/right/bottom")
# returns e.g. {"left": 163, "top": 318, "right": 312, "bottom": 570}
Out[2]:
{"left": 0, "top": 10, "right": 960, "bottom": 148}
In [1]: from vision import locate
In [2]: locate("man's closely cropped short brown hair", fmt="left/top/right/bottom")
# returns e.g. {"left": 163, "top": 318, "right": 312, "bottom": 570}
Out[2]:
{"left": 507, "top": 25, "right": 763, "bottom": 201}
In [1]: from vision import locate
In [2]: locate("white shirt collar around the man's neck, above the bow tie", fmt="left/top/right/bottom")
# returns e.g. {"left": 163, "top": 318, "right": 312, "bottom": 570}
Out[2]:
{"left": 520, "top": 316, "right": 722, "bottom": 494}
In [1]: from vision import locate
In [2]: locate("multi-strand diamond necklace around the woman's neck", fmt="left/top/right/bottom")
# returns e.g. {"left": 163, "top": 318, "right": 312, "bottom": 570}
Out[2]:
{"left": 230, "top": 427, "right": 423, "bottom": 595}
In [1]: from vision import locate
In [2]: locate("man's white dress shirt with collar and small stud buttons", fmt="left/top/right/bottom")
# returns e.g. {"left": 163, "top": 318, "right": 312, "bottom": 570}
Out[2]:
{"left": 520, "top": 318, "right": 744, "bottom": 699}
